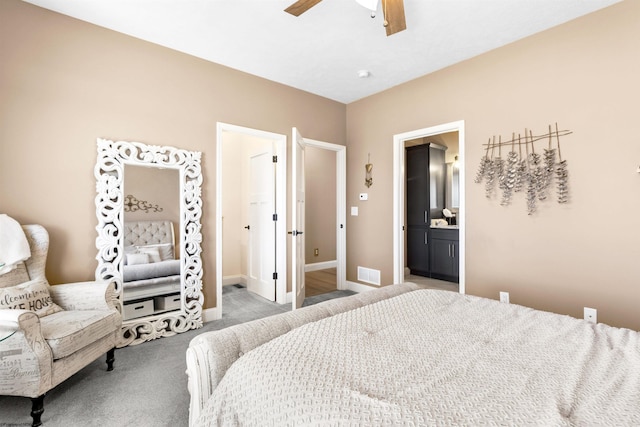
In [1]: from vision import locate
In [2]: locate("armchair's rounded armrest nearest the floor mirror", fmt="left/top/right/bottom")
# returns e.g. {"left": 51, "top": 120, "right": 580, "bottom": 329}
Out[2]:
{"left": 49, "top": 282, "right": 117, "bottom": 310}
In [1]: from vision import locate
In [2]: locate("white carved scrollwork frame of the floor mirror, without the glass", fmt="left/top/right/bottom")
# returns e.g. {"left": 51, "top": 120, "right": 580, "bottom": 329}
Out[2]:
{"left": 94, "top": 138, "right": 204, "bottom": 347}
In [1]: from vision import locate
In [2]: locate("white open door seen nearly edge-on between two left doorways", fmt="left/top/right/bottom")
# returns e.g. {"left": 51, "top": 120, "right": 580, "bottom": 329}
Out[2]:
{"left": 291, "top": 128, "right": 305, "bottom": 310}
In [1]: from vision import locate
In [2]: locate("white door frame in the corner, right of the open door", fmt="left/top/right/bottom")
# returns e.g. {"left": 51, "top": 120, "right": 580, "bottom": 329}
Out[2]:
{"left": 304, "top": 138, "right": 347, "bottom": 290}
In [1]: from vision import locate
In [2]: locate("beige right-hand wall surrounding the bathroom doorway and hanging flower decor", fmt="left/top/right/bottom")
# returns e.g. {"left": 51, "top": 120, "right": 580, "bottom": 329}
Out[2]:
{"left": 347, "top": 1, "right": 640, "bottom": 329}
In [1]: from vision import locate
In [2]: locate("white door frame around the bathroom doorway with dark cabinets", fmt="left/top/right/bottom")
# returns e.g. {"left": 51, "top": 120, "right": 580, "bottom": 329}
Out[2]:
{"left": 393, "top": 120, "right": 466, "bottom": 294}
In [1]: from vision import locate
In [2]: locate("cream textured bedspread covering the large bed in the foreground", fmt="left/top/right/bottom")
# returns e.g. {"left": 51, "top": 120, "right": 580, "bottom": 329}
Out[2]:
{"left": 198, "top": 290, "right": 640, "bottom": 426}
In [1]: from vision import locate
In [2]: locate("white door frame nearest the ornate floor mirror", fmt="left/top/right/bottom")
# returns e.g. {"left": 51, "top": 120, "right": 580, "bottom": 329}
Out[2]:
{"left": 212, "top": 122, "right": 287, "bottom": 321}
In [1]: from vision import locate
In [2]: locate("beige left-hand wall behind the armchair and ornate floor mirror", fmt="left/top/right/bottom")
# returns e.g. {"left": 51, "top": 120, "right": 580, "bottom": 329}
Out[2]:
{"left": 0, "top": 0, "right": 346, "bottom": 307}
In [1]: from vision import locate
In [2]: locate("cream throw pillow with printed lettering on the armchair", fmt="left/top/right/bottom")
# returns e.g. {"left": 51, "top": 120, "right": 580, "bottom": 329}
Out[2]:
{"left": 0, "top": 280, "right": 62, "bottom": 317}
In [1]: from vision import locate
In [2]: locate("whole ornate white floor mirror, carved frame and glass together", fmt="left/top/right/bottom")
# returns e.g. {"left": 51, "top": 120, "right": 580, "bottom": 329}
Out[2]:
{"left": 94, "top": 138, "right": 204, "bottom": 347}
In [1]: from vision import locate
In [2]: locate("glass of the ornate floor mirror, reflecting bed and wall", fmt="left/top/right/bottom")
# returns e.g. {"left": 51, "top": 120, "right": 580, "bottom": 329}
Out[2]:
{"left": 122, "top": 165, "right": 181, "bottom": 320}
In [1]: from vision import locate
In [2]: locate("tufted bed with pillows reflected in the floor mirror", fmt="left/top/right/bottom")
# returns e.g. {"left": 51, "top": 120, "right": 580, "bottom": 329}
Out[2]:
{"left": 122, "top": 220, "right": 180, "bottom": 302}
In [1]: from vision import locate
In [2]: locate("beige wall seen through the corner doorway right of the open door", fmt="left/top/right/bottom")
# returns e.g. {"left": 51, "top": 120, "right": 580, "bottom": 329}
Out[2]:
{"left": 304, "top": 146, "right": 336, "bottom": 264}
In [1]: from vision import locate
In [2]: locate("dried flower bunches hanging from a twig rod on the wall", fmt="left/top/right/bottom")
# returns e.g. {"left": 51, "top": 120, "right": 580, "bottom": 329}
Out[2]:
{"left": 475, "top": 123, "right": 573, "bottom": 215}
